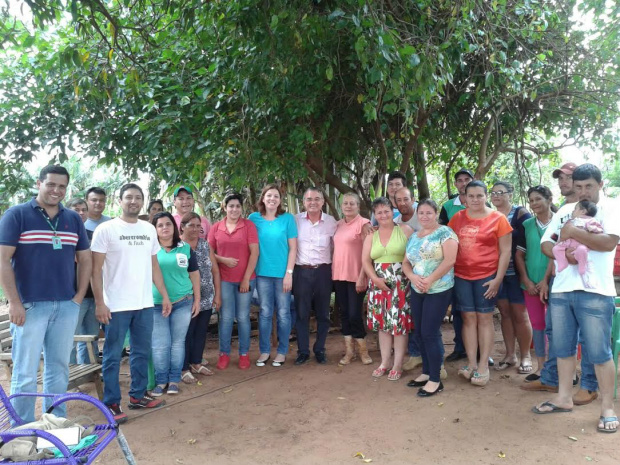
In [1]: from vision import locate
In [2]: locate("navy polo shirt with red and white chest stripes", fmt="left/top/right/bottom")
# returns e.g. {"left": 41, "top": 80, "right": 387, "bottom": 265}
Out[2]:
{"left": 0, "top": 198, "right": 89, "bottom": 302}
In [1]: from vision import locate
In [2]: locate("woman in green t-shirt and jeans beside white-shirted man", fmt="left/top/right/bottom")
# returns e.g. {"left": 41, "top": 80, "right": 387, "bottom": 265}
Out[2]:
{"left": 151, "top": 212, "right": 200, "bottom": 397}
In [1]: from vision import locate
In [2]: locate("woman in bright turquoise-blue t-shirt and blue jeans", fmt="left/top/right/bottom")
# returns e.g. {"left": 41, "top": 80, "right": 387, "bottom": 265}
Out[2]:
{"left": 248, "top": 184, "right": 297, "bottom": 367}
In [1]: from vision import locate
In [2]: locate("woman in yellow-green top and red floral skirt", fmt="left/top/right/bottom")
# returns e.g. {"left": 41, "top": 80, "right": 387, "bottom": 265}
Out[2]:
{"left": 362, "top": 197, "right": 413, "bottom": 381}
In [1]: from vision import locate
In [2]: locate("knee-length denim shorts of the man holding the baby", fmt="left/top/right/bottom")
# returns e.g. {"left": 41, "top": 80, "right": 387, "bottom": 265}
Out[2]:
{"left": 548, "top": 291, "right": 615, "bottom": 365}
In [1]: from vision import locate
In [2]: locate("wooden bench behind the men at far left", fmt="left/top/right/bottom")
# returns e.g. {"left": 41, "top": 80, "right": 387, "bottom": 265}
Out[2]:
{"left": 0, "top": 315, "right": 103, "bottom": 400}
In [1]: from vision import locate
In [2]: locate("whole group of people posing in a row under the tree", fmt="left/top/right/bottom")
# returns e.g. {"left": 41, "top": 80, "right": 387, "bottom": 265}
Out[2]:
{"left": 0, "top": 163, "right": 620, "bottom": 432}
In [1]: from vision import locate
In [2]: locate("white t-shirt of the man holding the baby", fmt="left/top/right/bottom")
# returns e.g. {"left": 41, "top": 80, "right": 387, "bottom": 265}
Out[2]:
{"left": 540, "top": 195, "right": 620, "bottom": 297}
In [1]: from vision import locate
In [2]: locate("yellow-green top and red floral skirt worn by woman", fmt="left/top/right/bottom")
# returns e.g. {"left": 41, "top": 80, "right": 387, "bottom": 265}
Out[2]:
{"left": 367, "top": 226, "right": 413, "bottom": 336}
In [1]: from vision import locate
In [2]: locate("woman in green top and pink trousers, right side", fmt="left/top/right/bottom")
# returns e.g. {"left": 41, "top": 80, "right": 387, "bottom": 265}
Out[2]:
{"left": 515, "top": 186, "right": 553, "bottom": 381}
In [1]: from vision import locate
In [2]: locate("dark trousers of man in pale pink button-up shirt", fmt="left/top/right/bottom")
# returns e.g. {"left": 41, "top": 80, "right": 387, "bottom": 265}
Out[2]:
{"left": 293, "top": 264, "right": 332, "bottom": 355}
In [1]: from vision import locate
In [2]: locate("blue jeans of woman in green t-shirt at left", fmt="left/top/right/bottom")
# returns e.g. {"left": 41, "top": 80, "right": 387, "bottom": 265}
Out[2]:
{"left": 152, "top": 296, "right": 194, "bottom": 385}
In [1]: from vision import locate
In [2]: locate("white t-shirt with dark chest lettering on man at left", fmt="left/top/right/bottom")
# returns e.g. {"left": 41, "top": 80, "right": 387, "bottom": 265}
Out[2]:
{"left": 90, "top": 218, "right": 161, "bottom": 312}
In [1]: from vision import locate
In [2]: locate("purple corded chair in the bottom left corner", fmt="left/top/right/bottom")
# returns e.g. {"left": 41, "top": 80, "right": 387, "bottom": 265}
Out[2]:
{"left": 0, "top": 386, "right": 118, "bottom": 465}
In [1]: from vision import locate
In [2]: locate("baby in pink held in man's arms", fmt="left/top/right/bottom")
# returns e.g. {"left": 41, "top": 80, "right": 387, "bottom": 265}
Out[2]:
{"left": 553, "top": 200, "right": 603, "bottom": 287}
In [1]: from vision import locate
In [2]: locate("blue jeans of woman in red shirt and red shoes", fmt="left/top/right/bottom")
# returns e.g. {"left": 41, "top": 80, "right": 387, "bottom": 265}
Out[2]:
{"left": 219, "top": 279, "right": 256, "bottom": 355}
